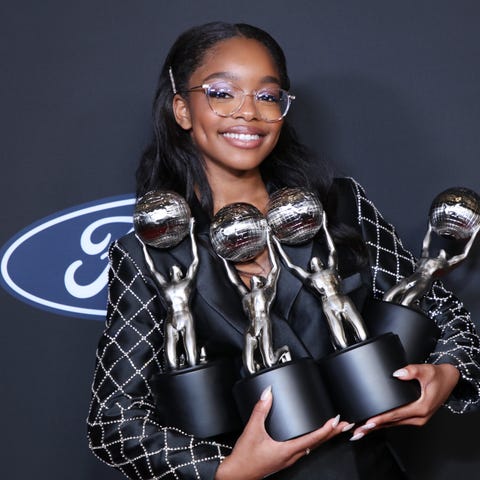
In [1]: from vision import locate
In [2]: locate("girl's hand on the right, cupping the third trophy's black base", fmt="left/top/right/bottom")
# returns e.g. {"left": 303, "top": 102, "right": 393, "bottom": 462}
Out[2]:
{"left": 350, "top": 363, "right": 460, "bottom": 440}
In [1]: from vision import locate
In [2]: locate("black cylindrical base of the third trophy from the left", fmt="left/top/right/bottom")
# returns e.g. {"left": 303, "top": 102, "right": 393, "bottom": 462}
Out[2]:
{"left": 319, "top": 333, "right": 420, "bottom": 423}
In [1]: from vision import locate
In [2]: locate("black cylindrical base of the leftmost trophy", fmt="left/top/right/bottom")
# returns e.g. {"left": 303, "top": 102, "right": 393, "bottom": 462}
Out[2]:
{"left": 151, "top": 359, "right": 242, "bottom": 438}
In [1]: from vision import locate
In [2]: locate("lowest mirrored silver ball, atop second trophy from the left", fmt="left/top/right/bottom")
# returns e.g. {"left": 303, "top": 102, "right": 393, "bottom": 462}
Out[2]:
{"left": 210, "top": 203, "right": 268, "bottom": 262}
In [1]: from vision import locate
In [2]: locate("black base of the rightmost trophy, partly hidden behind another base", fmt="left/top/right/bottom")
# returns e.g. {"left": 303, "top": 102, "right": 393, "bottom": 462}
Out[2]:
{"left": 362, "top": 299, "right": 440, "bottom": 364}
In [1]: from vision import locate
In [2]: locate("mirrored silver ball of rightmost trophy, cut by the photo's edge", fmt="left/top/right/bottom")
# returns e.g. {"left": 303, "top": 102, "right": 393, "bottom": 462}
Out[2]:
{"left": 429, "top": 187, "right": 480, "bottom": 240}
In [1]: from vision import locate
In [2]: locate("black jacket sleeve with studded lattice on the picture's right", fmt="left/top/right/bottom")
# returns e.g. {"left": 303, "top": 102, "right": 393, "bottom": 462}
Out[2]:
{"left": 344, "top": 180, "right": 480, "bottom": 413}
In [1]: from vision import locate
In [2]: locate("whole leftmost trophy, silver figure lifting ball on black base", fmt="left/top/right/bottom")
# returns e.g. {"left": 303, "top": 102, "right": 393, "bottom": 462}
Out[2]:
{"left": 133, "top": 191, "right": 240, "bottom": 438}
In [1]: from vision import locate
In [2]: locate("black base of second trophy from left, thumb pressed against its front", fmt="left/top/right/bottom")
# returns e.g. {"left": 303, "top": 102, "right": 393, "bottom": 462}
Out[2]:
{"left": 233, "top": 358, "right": 337, "bottom": 441}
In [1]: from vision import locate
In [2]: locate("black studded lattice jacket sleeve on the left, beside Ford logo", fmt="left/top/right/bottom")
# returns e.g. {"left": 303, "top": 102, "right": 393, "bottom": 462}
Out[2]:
{"left": 87, "top": 238, "right": 231, "bottom": 480}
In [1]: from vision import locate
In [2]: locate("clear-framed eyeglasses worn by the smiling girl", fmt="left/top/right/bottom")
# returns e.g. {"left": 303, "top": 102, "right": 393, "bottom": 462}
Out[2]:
{"left": 187, "top": 82, "right": 295, "bottom": 123}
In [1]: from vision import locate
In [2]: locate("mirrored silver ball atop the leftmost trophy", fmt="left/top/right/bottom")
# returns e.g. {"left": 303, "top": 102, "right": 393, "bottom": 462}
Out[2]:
{"left": 133, "top": 190, "right": 191, "bottom": 248}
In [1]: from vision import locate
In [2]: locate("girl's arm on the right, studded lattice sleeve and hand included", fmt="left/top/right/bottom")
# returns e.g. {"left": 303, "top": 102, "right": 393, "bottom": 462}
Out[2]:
{"left": 344, "top": 177, "right": 480, "bottom": 438}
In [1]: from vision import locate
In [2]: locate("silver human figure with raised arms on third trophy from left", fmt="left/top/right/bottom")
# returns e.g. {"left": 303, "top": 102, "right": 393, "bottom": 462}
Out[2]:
{"left": 275, "top": 209, "right": 367, "bottom": 349}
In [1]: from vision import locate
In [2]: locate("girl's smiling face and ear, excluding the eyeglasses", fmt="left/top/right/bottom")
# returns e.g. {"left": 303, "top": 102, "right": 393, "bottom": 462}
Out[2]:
{"left": 173, "top": 37, "right": 283, "bottom": 179}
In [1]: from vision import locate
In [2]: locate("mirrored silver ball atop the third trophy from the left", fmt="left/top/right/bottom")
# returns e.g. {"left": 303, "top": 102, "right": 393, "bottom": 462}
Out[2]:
{"left": 267, "top": 188, "right": 323, "bottom": 245}
